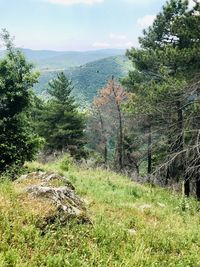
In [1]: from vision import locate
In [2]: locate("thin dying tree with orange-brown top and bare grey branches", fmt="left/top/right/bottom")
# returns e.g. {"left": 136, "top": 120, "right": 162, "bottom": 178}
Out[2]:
{"left": 88, "top": 77, "right": 126, "bottom": 170}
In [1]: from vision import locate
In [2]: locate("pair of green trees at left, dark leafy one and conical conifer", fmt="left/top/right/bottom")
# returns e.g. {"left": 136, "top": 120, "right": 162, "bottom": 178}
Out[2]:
{"left": 0, "top": 29, "right": 85, "bottom": 179}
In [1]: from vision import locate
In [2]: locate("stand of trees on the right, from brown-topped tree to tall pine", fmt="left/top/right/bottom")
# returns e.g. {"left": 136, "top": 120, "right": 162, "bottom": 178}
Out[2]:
{"left": 88, "top": 0, "right": 200, "bottom": 198}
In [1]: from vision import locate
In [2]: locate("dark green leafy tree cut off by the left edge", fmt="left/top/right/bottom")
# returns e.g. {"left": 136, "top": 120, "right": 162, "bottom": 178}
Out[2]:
{"left": 0, "top": 30, "right": 40, "bottom": 176}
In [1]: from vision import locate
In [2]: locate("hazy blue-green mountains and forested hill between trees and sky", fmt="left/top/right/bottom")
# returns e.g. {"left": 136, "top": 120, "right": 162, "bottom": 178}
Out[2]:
{"left": 0, "top": 49, "right": 132, "bottom": 102}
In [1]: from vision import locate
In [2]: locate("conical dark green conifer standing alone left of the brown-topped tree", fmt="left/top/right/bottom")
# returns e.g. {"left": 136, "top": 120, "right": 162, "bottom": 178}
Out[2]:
{"left": 39, "top": 72, "right": 84, "bottom": 157}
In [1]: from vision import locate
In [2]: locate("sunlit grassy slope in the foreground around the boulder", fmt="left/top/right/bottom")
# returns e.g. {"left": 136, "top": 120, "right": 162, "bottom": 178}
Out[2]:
{"left": 0, "top": 162, "right": 200, "bottom": 267}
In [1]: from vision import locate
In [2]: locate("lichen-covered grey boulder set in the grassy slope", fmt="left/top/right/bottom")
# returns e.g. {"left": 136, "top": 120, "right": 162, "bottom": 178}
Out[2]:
{"left": 16, "top": 172, "right": 91, "bottom": 225}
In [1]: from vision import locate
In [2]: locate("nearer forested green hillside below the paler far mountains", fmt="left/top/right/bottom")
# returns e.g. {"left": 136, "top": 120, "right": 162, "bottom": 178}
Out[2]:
{"left": 35, "top": 56, "right": 132, "bottom": 102}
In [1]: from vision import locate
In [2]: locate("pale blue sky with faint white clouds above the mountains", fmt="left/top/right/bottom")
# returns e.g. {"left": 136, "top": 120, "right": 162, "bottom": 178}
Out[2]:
{"left": 0, "top": 0, "right": 194, "bottom": 51}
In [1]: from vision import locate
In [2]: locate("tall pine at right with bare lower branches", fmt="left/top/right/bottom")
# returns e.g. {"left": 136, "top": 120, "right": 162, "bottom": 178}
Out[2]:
{"left": 124, "top": 0, "right": 200, "bottom": 195}
